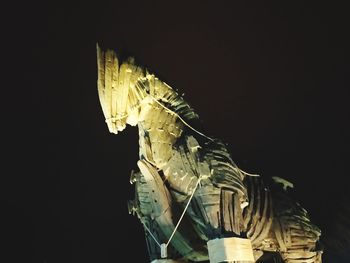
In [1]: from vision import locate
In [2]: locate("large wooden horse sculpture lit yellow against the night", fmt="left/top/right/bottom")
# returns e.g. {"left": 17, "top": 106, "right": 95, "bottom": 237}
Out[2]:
{"left": 97, "top": 47, "right": 322, "bottom": 263}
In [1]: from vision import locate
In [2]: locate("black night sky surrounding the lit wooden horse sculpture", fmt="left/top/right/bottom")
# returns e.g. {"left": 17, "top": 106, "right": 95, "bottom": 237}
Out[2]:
{"left": 0, "top": 1, "right": 350, "bottom": 263}
